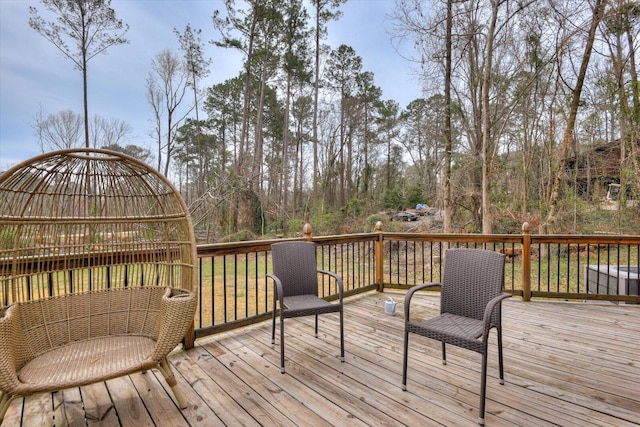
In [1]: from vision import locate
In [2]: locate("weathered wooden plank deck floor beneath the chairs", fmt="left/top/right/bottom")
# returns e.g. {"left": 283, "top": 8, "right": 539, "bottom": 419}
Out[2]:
{"left": 3, "top": 292, "right": 640, "bottom": 427}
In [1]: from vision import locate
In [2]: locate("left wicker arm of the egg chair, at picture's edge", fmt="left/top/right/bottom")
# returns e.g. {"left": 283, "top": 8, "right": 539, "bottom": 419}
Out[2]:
{"left": 0, "top": 304, "right": 26, "bottom": 391}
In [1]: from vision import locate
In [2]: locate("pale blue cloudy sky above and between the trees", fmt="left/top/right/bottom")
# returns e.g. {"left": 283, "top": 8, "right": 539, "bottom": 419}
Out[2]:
{"left": 0, "top": 0, "right": 421, "bottom": 171}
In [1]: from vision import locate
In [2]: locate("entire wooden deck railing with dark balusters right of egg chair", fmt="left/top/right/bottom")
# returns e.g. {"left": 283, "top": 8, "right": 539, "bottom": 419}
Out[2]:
{"left": 196, "top": 224, "right": 640, "bottom": 337}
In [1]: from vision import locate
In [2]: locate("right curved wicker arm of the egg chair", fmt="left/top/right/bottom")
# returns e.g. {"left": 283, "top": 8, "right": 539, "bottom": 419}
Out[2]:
{"left": 150, "top": 288, "right": 198, "bottom": 362}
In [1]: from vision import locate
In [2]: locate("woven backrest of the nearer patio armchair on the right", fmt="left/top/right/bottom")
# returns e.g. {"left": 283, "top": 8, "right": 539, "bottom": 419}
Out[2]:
{"left": 440, "top": 248, "right": 505, "bottom": 321}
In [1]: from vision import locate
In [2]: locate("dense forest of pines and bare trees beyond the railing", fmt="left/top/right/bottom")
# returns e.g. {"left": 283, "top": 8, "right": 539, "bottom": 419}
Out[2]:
{"left": 27, "top": 0, "right": 640, "bottom": 242}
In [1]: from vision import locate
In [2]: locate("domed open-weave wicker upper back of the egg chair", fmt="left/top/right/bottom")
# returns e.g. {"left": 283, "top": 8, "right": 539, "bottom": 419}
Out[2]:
{"left": 0, "top": 148, "right": 197, "bottom": 306}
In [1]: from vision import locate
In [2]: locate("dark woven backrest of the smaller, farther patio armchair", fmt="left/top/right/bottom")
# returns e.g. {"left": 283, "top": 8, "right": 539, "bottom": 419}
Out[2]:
{"left": 271, "top": 242, "right": 318, "bottom": 297}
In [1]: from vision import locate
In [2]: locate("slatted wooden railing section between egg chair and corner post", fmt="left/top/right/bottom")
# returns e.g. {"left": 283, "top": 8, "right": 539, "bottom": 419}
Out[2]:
{"left": 195, "top": 227, "right": 379, "bottom": 337}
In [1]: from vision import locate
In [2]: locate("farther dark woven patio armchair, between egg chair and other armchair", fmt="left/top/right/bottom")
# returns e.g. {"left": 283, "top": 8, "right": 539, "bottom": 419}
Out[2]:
{"left": 267, "top": 242, "right": 344, "bottom": 374}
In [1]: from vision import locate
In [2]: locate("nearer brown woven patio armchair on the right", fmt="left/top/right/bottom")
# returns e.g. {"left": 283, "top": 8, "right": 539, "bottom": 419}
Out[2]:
{"left": 402, "top": 249, "right": 511, "bottom": 425}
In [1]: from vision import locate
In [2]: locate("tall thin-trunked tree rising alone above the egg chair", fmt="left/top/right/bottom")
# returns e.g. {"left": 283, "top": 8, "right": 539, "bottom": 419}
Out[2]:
{"left": 29, "top": 0, "right": 129, "bottom": 147}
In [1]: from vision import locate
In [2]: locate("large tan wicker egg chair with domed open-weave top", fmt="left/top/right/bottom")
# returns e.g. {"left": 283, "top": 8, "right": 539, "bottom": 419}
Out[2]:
{"left": 0, "top": 149, "right": 197, "bottom": 423}
